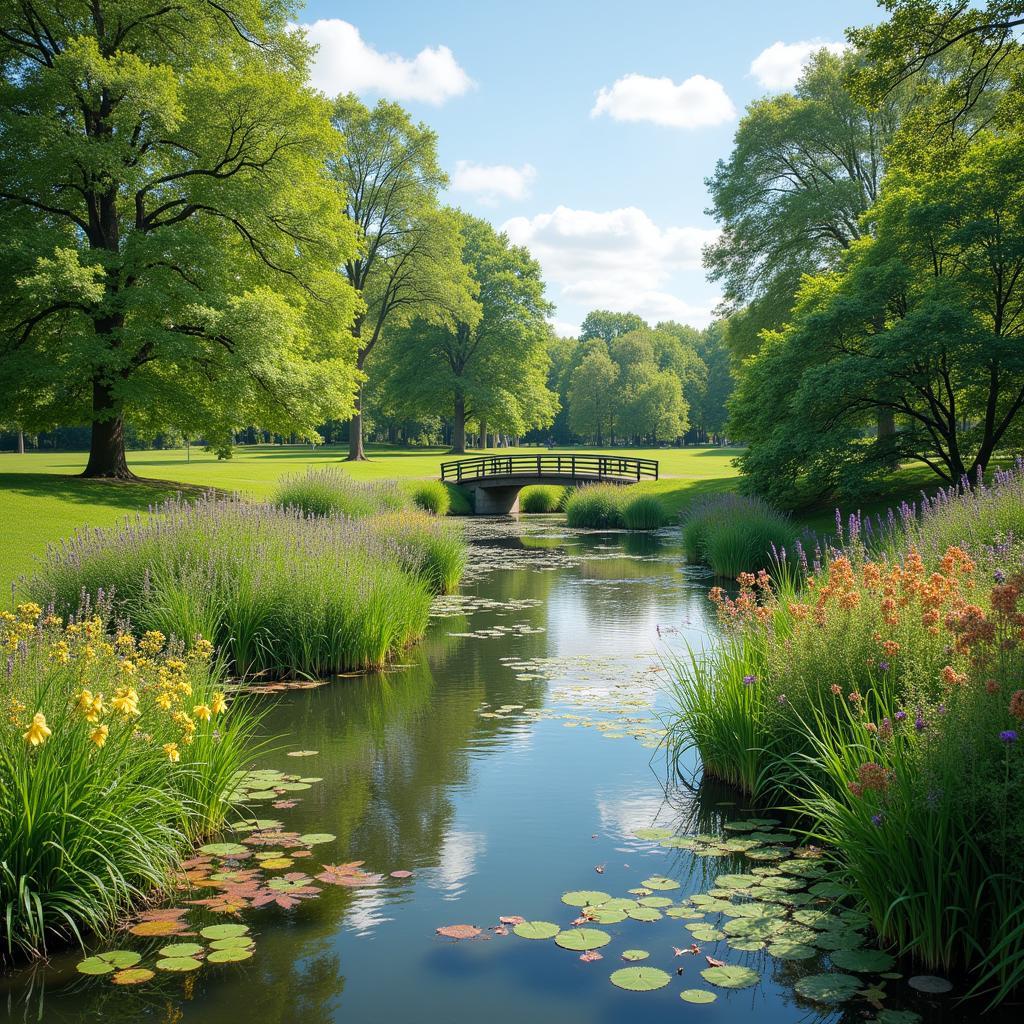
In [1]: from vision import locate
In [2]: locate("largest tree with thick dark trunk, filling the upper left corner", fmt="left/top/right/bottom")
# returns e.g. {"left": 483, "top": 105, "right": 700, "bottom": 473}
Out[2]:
{"left": 0, "top": 0, "right": 357, "bottom": 477}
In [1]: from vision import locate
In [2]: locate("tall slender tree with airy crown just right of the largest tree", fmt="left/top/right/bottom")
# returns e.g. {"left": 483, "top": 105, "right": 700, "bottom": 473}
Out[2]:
{"left": 335, "top": 95, "right": 473, "bottom": 461}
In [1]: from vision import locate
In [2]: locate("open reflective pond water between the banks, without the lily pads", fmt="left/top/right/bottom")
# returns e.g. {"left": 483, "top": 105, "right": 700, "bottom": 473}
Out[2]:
{"left": 0, "top": 519, "right": 1007, "bottom": 1024}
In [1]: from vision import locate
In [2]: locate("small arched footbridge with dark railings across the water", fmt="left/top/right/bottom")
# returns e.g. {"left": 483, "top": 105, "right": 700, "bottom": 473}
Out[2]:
{"left": 441, "top": 452, "right": 657, "bottom": 515}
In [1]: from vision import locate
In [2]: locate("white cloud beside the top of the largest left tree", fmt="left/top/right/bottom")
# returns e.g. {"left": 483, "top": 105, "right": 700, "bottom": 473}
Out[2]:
{"left": 302, "top": 17, "right": 473, "bottom": 104}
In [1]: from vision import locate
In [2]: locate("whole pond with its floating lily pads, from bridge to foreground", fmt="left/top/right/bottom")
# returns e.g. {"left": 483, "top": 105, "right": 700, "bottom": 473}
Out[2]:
{"left": 0, "top": 517, "right": 1007, "bottom": 1024}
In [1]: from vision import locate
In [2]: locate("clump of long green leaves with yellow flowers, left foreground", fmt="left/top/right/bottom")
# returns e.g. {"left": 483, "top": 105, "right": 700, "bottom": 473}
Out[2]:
{"left": 0, "top": 602, "right": 257, "bottom": 961}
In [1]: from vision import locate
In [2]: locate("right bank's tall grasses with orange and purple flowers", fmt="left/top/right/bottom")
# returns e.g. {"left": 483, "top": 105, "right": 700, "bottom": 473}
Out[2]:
{"left": 669, "top": 461, "right": 1024, "bottom": 1005}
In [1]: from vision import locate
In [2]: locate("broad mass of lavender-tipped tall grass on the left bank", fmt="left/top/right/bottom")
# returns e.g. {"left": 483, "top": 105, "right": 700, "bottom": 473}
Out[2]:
{"left": 23, "top": 496, "right": 464, "bottom": 677}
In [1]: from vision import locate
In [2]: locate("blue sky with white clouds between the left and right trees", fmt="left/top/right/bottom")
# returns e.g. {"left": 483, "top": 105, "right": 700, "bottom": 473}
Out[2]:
{"left": 301, "top": 0, "right": 880, "bottom": 334}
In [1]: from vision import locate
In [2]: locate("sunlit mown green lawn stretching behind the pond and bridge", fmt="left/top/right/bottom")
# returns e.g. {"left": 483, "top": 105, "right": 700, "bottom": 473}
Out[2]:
{"left": 0, "top": 445, "right": 736, "bottom": 589}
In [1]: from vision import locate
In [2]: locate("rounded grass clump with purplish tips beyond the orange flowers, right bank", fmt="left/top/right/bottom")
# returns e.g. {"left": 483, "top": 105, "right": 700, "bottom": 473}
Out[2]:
{"left": 682, "top": 495, "right": 797, "bottom": 579}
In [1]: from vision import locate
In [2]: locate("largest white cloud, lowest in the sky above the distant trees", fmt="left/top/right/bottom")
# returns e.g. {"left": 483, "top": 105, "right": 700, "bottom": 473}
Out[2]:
{"left": 502, "top": 206, "right": 718, "bottom": 327}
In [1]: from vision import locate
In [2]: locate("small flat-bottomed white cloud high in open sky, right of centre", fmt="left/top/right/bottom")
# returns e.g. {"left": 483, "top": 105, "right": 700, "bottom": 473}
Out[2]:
{"left": 590, "top": 75, "right": 736, "bottom": 128}
